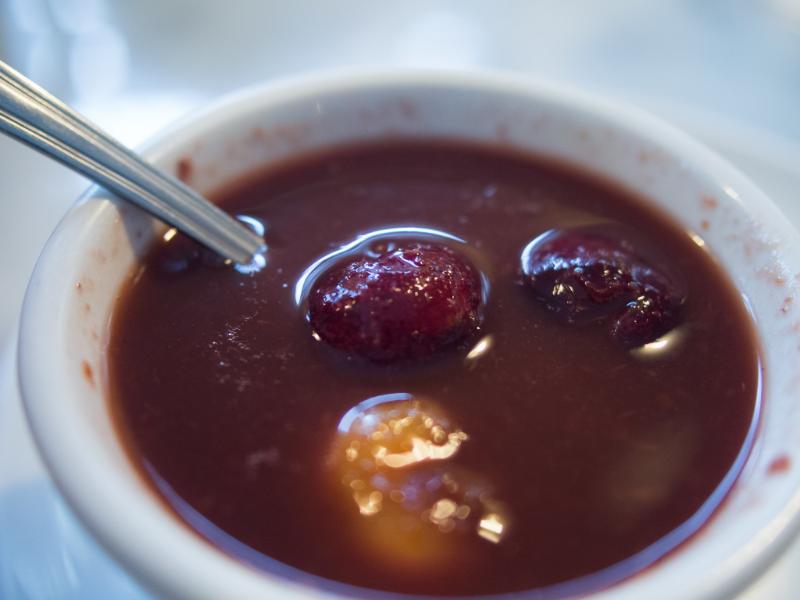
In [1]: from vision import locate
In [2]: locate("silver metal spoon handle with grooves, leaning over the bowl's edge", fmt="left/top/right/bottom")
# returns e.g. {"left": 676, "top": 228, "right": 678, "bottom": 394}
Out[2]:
{"left": 0, "top": 61, "right": 264, "bottom": 264}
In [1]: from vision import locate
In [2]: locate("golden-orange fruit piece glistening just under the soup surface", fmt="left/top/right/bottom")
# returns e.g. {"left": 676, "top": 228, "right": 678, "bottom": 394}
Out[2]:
{"left": 329, "top": 394, "right": 508, "bottom": 569}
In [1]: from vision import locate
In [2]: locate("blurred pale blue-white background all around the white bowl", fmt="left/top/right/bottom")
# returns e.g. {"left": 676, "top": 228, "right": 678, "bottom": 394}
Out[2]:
{"left": 0, "top": 0, "right": 800, "bottom": 600}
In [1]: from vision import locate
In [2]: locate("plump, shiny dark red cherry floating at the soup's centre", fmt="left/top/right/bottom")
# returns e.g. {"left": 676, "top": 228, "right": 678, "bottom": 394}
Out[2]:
{"left": 308, "top": 242, "right": 481, "bottom": 362}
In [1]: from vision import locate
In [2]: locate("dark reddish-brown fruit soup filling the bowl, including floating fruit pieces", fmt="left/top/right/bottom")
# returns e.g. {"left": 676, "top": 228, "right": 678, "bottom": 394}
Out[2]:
{"left": 109, "top": 142, "right": 759, "bottom": 598}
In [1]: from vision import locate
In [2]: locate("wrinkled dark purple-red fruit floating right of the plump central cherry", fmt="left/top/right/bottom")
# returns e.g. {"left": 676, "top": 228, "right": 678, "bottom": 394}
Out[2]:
{"left": 522, "top": 229, "right": 685, "bottom": 348}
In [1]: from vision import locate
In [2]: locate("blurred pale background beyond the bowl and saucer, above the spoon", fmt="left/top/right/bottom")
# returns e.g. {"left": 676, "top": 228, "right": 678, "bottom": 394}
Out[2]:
{"left": 0, "top": 0, "right": 800, "bottom": 139}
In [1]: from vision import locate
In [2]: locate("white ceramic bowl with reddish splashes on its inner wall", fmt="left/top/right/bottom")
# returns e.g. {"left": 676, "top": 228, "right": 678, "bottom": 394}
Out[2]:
{"left": 19, "top": 73, "right": 800, "bottom": 600}
